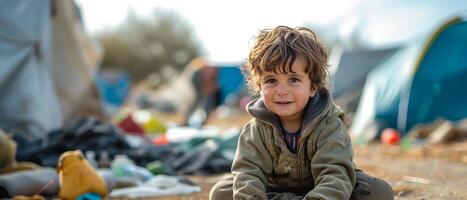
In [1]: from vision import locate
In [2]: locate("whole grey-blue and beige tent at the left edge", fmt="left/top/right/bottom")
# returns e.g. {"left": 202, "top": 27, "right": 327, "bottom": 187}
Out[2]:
{"left": 0, "top": 0, "right": 104, "bottom": 141}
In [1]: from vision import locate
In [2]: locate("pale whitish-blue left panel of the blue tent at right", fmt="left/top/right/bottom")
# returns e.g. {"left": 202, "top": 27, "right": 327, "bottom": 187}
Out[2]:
{"left": 350, "top": 45, "right": 421, "bottom": 140}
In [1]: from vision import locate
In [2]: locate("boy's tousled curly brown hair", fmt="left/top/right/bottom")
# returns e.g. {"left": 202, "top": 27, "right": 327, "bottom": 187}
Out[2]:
{"left": 243, "top": 26, "right": 329, "bottom": 94}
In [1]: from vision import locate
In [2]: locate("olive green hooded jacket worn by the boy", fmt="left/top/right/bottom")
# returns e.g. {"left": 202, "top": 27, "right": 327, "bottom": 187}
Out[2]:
{"left": 232, "top": 91, "right": 356, "bottom": 199}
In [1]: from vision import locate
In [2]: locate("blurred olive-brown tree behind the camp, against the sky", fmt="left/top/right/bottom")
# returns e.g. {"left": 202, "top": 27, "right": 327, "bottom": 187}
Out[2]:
{"left": 98, "top": 8, "right": 201, "bottom": 83}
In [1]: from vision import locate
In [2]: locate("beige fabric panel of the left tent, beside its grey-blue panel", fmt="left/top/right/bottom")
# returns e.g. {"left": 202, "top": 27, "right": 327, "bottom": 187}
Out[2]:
{"left": 51, "top": 0, "right": 106, "bottom": 124}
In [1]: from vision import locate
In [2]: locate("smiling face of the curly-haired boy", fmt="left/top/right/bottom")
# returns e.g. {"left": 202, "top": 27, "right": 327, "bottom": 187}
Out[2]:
{"left": 260, "top": 57, "right": 316, "bottom": 122}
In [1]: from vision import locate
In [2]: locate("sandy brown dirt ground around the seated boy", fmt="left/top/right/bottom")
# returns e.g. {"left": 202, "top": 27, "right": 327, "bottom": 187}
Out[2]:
{"left": 150, "top": 113, "right": 467, "bottom": 200}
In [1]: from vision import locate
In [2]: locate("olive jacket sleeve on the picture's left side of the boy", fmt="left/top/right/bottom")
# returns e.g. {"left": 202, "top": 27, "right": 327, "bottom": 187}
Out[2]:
{"left": 232, "top": 121, "right": 272, "bottom": 199}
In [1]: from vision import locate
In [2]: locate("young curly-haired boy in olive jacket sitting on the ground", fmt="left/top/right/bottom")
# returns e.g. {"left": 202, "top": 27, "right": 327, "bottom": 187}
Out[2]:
{"left": 210, "top": 26, "right": 394, "bottom": 200}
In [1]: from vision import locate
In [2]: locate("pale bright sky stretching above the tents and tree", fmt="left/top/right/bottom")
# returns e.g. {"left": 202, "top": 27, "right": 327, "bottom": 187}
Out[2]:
{"left": 76, "top": 0, "right": 467, "bottom": 63}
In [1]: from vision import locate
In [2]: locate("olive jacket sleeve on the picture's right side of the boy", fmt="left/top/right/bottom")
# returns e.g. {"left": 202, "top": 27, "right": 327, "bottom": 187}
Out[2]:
{"left": 305, "top": 117, "right": 356, "bottom": 199}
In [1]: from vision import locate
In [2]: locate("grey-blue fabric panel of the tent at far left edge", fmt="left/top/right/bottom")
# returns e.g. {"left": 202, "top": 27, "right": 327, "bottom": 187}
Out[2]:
{"left": 0, "top": 0, "right": 63, "bottom": 142}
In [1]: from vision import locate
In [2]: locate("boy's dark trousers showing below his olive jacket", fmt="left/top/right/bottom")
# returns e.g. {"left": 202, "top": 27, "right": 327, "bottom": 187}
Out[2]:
{"left": 209, "top": 170, "right": 394, "bottom": 200}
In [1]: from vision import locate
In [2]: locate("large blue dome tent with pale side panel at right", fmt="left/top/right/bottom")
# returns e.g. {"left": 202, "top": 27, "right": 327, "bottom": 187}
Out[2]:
{"left": 351, "top": 14, "right": 467, "bottom": 139}
